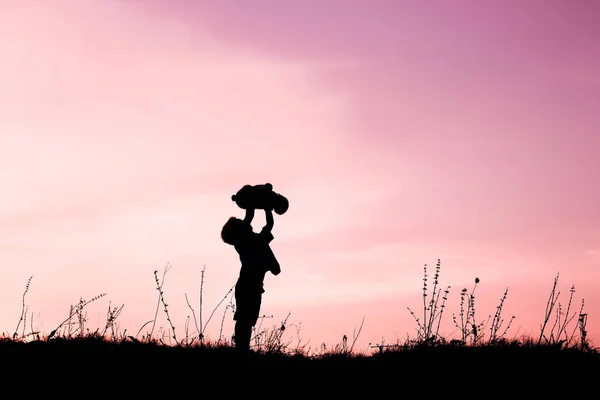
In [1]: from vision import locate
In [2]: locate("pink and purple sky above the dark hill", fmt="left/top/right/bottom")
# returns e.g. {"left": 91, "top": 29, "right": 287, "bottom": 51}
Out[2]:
{"left": 0, "top": 0, "right": 600, "bottom": 348}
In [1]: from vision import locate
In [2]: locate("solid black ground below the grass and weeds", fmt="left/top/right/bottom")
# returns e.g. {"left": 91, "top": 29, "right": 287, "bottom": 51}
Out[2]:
{"left": 0, "top": 339, "right": 600, "bottom": 398}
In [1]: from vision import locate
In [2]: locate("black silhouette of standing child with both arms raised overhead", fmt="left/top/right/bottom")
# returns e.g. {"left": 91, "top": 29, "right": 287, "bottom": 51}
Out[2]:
{"left": 221, "top": 209, "right": 281, "bottom": 350}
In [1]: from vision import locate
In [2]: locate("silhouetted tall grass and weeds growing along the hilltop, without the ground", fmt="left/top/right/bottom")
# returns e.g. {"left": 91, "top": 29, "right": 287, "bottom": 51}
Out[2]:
{"left": 0, "top": 259, "right": 597, "bottom": 359}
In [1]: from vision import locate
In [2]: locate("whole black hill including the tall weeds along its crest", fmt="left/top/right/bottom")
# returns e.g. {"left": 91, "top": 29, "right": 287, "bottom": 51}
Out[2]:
{"left": 0, "top": 260, "right": 600, "bottom": 392}
